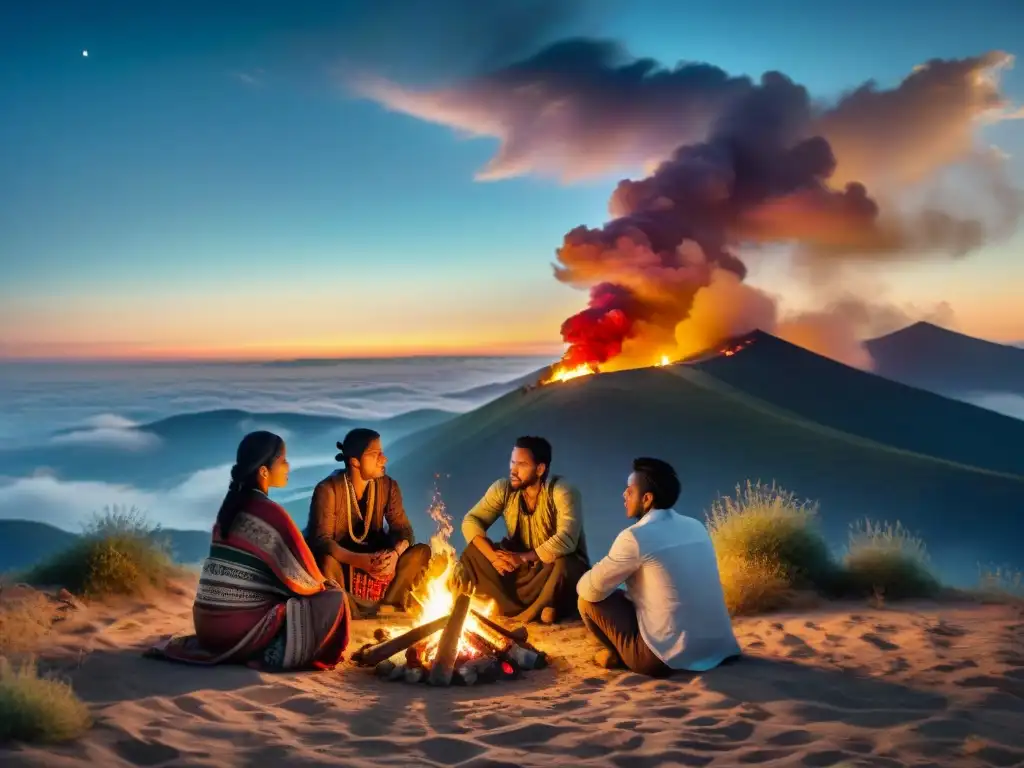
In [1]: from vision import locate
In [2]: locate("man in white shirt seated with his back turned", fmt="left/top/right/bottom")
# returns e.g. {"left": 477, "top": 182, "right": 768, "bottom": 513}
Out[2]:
{"left": 577, "top": 458, "right": 740, "bottom": 677}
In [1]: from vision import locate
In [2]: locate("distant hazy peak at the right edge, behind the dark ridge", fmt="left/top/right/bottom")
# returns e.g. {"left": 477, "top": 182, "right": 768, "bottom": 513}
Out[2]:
{"left": 865, "top": 323, "right": 1024, "bottom": 396}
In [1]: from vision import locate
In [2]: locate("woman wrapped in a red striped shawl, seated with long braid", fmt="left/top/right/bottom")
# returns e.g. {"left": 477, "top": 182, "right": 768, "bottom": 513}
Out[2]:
{"left": 148, "top": 432, "right": 350, "bottom": 670}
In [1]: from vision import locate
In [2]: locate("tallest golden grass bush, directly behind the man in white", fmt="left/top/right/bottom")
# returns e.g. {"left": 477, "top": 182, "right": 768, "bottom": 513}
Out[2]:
{"left": 708, "top": 481, "right": 836, "bottom": 614}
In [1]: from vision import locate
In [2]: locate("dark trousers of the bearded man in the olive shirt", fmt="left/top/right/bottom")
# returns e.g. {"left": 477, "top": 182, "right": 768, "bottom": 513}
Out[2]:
{"left": 460, "top": 542, "right": 588, "bottom": 622}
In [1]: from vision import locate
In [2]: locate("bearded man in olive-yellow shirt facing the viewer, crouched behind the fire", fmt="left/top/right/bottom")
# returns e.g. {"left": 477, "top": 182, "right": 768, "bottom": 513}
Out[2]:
{"left": 461, "top": 436, "right": 590, "bottom": 624}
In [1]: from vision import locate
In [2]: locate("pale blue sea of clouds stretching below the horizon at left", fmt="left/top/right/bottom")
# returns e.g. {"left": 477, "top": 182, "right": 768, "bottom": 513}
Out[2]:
{"left": 0, "top": 357, "right": 551, "bottom": 531}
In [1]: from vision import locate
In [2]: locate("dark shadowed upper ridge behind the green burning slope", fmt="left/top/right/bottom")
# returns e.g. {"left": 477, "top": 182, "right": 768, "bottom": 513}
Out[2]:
{"left": 693, "top": 333, "right": 1024, "bottom": 474}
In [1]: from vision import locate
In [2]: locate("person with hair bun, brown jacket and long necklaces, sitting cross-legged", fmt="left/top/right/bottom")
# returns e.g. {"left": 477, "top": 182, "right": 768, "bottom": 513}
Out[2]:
{"left": 306, "top": 427, "right": 430, "bottom": 617}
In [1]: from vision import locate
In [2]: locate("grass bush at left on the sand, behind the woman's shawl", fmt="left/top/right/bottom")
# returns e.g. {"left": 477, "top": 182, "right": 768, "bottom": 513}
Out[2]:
{"left": 27, "top": 507, "right": 177, "bottom": 599}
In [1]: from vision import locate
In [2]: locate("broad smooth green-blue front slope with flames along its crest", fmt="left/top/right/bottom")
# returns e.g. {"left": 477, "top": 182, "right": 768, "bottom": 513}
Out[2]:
{"left": 380, "top": 364, "right": 1024, "bottom": 582}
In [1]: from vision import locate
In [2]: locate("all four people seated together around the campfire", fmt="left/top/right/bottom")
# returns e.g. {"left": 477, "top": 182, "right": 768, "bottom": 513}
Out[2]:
{"left": 151, "top": 428, "right": 740, "bottom": 677}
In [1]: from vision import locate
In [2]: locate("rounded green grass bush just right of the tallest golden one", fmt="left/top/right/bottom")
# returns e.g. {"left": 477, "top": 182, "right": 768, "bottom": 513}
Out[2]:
{"left": 843, "top": 519, "right": 941, "bottom": 600}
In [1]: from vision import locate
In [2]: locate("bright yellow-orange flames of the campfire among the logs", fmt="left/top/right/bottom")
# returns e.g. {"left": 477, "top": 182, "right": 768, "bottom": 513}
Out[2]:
{"left": 413, "top": 485, "right": 496, "bottom": 664}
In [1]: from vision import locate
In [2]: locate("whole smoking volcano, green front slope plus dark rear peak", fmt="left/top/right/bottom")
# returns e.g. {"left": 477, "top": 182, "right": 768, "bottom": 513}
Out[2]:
{"left": 389, "top": 336, "right": 1024, "bottom": 584}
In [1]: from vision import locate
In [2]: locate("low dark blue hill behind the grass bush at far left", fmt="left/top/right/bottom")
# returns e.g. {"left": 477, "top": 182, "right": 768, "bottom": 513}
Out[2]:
{"left": 0, "top": 520, "right": 210, "bottom": 573}
